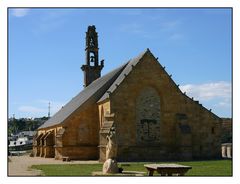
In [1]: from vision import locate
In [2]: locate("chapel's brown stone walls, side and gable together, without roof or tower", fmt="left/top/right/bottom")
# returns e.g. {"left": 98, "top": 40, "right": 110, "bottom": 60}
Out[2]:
{"left": 34, "top": 52, "right": 221, "bottom": 161}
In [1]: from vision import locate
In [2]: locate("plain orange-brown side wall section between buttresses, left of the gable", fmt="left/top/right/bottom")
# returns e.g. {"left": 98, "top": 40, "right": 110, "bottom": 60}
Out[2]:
{"left": 59, "top": 104, "right": 99, "bottom": 159}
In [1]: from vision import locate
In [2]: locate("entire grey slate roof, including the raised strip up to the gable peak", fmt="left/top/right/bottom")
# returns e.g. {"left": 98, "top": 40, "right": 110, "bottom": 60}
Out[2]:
{"left": 38, "top": 49, "right": 218, "bottom": 129}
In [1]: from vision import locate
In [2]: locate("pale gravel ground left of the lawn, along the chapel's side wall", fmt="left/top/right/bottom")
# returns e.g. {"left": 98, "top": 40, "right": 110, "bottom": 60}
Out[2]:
{"left": 8, "top": 155, "right": 99, "bottom": 176}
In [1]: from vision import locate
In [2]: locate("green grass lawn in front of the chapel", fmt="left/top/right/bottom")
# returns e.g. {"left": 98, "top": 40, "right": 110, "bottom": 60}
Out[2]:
{"left": 32, "top": 160, "right": 232, "bottom": 176}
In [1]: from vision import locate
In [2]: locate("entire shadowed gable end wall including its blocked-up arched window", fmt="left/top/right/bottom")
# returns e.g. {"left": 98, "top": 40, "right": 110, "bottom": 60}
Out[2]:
{"left": 107, "top": 53, "right": 221, "bottom": 160}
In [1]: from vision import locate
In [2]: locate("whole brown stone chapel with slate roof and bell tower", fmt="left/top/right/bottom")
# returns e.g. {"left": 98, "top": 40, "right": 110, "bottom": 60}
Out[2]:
{"left": 33, "top": 26, "right": 222, "bottom": 161}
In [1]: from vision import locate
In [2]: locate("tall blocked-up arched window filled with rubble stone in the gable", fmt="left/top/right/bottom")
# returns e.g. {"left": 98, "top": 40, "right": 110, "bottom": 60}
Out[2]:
{"left": 136, "top": 87, "right": 160, "bottom": 143}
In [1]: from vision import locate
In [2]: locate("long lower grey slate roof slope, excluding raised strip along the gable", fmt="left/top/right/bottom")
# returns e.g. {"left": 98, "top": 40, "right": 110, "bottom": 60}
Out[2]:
{"left": 38, "top": 63, "right": 127, "bottom": 129}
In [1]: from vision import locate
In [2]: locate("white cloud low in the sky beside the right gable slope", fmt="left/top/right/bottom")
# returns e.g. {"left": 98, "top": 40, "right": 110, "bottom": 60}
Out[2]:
{"left": 180, "top": 81, "right": 231, "bottom": 101}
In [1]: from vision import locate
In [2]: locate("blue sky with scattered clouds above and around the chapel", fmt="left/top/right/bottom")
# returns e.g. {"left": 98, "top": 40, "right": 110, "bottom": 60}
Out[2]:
{"left": 8, "top": 8, "right": 232, "bottom": 118}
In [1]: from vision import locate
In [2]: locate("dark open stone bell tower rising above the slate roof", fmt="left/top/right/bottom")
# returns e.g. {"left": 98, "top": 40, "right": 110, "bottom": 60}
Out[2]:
{"left": 81, "top": 25, "right": 104, "bottom": 87}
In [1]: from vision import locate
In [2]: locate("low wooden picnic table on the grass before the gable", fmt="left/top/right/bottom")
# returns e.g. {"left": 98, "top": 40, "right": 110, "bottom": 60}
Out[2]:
{"left": 144, "top": 164, "right": 192, "bottom": 176}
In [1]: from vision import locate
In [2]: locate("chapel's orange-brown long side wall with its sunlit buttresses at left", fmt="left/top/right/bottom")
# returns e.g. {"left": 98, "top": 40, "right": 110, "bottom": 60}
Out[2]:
{"left": 34, "top": 103, "right": 99, "bottom": 160}
